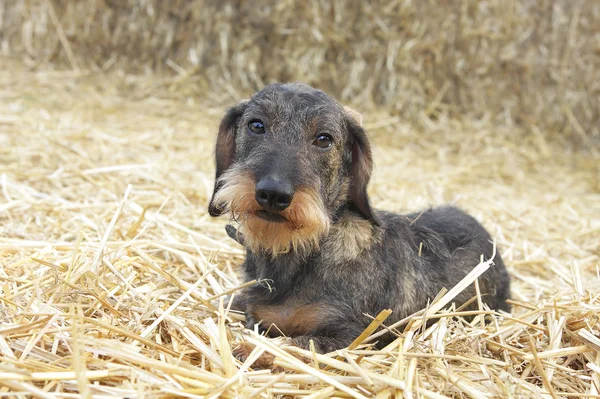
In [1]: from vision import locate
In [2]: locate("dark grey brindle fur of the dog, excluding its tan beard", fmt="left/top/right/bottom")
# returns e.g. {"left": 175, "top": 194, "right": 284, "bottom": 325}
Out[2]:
{"left": 210, "top": 84, "right": 510, "bottom": 352}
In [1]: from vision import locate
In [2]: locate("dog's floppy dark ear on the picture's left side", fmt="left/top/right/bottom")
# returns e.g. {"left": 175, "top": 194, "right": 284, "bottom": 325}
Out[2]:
{"left": 208, "top": 100, "right": 248, "bottom": 216}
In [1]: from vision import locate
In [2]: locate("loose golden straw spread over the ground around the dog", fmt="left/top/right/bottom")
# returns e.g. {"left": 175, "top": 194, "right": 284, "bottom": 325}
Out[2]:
{"left": 0, "top": 60, "right": 600, "bottom": 398}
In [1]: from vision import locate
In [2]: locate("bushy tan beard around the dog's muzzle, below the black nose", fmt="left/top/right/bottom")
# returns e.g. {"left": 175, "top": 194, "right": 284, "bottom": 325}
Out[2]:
{"left": 214, "top": 166, "right": 329, "bottom": 256}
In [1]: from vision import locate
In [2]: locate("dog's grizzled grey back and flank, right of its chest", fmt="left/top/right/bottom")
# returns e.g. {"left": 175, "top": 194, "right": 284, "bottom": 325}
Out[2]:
{"left": 318, "top": 206, "right": 510, "bottom": 342}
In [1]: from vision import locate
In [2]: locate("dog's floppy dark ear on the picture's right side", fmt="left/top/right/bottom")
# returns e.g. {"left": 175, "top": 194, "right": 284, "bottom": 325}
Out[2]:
{"left": 344, "top": 107, "right": 379, "bottom": 225}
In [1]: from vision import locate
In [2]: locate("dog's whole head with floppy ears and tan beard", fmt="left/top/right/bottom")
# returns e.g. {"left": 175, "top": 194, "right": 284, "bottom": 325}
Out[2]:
{"left": 209, "top": 83, "right": 377, "bottom": 255}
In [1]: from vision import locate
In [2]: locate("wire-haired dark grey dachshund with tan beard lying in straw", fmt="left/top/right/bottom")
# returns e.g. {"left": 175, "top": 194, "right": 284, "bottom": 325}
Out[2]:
{"left": 209, "top": 83, "right": 510, "bottom": 353}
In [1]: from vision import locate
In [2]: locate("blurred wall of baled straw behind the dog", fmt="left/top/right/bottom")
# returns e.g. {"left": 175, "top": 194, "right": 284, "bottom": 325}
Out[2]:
{"left": 0, "top": 0, "right": 600, "bottom": 147}
